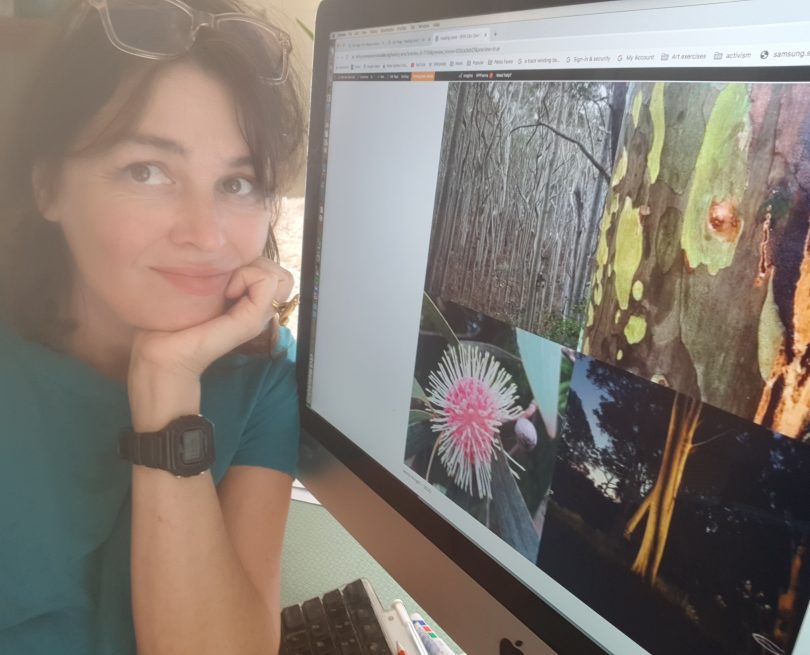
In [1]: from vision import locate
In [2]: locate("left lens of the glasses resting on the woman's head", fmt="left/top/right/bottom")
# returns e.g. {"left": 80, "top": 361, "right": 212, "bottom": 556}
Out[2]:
{"left": 107, "top": 0, "right": 193, "bottom": 56}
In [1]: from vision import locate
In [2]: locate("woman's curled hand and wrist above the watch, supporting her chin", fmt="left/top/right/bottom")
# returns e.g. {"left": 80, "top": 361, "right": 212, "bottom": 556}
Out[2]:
{"left": 128, "top": 257, "right": 293, "bottom": 431}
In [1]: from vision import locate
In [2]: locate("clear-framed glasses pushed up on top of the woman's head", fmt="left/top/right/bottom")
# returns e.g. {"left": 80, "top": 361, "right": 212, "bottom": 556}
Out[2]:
{"left": 85, "top": 0, "right": 292, "bottom": 84}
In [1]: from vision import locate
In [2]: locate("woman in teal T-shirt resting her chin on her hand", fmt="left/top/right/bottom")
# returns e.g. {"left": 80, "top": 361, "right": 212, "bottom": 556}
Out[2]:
{"left": 0, "top": 0, "right": 303, "bottom": 654}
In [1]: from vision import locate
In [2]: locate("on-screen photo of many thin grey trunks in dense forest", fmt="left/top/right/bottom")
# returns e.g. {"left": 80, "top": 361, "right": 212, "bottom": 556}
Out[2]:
{"left": 426, "top": 82, "right": 626, "bottom": 347}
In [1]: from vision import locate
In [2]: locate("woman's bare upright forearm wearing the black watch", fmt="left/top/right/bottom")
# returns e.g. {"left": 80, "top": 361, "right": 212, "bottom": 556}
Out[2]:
{"left": 130, "top": 378, "right": 280, "bottom": 655}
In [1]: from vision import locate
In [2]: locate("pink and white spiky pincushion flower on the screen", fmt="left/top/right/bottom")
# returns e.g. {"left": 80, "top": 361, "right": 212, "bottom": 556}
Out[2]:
{"left": 427, "top": 344, "right": 521, "bottom": 498}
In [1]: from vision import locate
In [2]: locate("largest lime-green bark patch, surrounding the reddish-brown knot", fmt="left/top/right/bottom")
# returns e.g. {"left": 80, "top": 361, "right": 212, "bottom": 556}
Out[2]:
{"left": 681, "top": 84, "right": 751, "bottom": 275}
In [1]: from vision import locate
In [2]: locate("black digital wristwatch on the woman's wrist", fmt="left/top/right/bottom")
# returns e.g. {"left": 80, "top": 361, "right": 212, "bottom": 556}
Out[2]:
{"left": 118, "top": 414, "right": 214, "bottom": 478}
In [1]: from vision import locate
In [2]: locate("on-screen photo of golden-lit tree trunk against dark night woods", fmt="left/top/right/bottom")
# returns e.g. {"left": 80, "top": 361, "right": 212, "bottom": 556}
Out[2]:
{"left": 538, "top": 355, "right": 810, "bottom": 655}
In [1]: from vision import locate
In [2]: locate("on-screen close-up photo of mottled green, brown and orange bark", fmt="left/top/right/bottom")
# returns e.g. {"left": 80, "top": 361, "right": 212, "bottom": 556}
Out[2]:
{"left": 582, "top": 82, "right": 810, "bottom": 439}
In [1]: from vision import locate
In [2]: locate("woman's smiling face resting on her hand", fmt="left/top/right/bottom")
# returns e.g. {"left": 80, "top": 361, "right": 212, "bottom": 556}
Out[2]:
{"left": 42, "top": 64, "right": 270, "bottom": 331}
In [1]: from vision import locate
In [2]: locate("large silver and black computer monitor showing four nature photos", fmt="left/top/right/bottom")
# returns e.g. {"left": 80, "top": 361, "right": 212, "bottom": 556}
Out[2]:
{"left": 299, "top": 0, "right": 810, "bottom": 655}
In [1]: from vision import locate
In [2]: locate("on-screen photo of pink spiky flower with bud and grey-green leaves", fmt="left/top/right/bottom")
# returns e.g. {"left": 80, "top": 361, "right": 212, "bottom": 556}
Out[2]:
{"left": 404, "top": 294, "right": 573, "bottom": 562}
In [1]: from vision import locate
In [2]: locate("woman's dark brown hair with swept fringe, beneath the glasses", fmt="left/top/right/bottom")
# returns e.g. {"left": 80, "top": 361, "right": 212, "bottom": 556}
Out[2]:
{"left": 0, "top": 0, "right": 305, "bottom": 351}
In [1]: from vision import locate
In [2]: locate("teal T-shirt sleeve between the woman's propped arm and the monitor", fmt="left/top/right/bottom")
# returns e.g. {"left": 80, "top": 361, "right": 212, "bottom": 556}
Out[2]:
{"left": 231, "top": 328, "right": 300, "bottom": 477}
